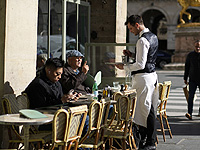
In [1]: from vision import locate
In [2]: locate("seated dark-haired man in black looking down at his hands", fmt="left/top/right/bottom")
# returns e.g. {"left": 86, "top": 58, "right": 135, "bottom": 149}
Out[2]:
{"left": 24, "top": 58, "right": 79, "bottom": 109}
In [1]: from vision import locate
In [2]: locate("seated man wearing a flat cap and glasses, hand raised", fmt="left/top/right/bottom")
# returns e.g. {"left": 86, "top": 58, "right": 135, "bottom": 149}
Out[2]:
{"left": 60, "top": 50, "right": 91, "bottom": 94}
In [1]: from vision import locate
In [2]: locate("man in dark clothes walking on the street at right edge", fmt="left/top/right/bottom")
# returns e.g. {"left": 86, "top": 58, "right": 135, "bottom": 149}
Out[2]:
{"left": 184, "top": 40, "right": 200, "bottom": 120}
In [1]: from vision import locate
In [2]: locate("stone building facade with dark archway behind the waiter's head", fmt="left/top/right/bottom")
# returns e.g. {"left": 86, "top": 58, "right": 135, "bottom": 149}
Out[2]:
{"left": 128, "top": 0, "right": 200, "bottom": 51}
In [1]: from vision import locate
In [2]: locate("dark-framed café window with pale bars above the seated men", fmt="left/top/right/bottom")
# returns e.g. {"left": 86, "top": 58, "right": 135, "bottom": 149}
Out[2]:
{"left": 37, "top": 0, "right": 90, "bottom": 60}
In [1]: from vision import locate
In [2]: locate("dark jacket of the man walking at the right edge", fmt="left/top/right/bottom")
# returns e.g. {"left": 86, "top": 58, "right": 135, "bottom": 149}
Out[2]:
{"left": 184, "top": 51, "right": 200, "bottom": 83}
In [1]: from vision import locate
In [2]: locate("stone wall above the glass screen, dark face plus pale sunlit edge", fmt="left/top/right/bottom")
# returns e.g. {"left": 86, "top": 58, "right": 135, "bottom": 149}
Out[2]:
{"left": 89, "top": 0, "right": 127, "bottom": 43}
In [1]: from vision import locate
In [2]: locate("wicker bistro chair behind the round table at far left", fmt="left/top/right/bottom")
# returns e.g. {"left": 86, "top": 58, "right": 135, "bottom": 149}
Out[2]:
{"left": 2, "top": 94, "right": 50, "bottom": 149}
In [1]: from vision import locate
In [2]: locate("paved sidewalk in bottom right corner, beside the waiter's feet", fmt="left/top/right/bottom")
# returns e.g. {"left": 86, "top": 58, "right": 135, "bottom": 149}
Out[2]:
{"left": 157, "top": 116, "right": 200, "bottom": 150}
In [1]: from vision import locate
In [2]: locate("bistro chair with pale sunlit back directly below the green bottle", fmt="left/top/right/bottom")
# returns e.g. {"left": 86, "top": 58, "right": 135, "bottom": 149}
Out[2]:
{"left": 78, "top": 100, "right": 104, "bottom": 150}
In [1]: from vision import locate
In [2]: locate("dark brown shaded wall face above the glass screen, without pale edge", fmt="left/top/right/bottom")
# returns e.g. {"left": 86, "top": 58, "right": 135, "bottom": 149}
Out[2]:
{"left": 89, "top": 0, "right": 116, "bottom": 43}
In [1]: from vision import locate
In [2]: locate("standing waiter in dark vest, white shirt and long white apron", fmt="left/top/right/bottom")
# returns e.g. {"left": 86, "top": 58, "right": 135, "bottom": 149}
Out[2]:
{"left": 116, "top": 15, "right": 158, "bottom": 150}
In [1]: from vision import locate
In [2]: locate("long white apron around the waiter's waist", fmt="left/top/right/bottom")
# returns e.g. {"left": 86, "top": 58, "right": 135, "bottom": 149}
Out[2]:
{"left": 132, "top": 72, "right": 159, "bottom": 127}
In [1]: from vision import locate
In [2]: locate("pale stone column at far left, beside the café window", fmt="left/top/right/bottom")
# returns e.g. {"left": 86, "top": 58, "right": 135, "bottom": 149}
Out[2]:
{"left": 0, "top": 0, "right": 38, "bottom": 148}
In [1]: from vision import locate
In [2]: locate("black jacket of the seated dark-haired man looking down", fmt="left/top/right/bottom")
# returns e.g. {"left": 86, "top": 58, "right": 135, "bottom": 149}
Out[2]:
{"left": 24, "top": 69, "right": 63, "bottom": 109}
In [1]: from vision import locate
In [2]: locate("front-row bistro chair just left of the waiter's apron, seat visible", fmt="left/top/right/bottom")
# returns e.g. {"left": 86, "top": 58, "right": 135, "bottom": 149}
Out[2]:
{"left": 104, "top": 95, "right": 135, "bottom": 150}
